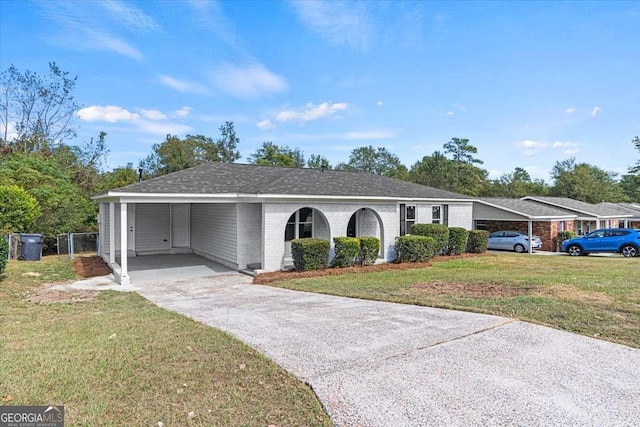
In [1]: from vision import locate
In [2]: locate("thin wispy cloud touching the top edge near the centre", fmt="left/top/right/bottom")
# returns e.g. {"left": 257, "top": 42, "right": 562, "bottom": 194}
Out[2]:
{"left": 290, "top": 1, "right": 373, "bottom": 49}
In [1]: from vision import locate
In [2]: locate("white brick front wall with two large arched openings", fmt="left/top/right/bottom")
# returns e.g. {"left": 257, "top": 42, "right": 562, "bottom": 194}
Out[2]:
{"left": 262, "top": 202, "right": 399, "bottom": 271}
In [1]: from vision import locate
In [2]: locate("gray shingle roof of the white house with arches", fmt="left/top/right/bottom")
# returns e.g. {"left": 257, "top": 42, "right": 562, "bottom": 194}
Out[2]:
{"left": 104, "top": 163, "right": 472, "bottom": 200}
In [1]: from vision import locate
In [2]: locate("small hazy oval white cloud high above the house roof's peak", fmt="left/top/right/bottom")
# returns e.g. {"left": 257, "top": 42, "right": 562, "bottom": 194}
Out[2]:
{"left": 212, "top": 64, "right": 288, "bottom": 98}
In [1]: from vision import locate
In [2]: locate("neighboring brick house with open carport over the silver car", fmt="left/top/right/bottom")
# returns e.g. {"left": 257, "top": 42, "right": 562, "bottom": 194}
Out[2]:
{"left": 473, "top": 197, "right": 578, "bottom": 251}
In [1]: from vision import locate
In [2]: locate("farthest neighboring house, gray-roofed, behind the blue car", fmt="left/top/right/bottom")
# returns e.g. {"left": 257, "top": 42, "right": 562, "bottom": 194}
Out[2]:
{"left": 522, "top": 196, "right": 633, "bottom": 235}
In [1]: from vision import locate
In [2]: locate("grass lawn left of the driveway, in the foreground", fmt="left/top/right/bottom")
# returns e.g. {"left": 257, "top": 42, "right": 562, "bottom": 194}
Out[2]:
{"left": 0, "top": 257, "right": 330, "bottom": 426}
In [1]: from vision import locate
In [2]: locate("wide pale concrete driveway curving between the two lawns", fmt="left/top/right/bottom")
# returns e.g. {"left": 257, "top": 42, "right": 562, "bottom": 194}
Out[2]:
{"left": 135, "top": 274, "right": 640, "bottom": 426}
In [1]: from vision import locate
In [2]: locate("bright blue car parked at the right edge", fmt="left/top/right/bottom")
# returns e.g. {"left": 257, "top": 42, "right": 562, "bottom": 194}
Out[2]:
{"left": 562, "top": 228, "right": 640, "bottom": 258}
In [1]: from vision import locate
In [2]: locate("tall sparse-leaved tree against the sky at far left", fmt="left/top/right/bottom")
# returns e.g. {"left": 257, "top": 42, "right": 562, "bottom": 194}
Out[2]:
{"left": 0, "top": 62, "right": 79, "bottom": 153}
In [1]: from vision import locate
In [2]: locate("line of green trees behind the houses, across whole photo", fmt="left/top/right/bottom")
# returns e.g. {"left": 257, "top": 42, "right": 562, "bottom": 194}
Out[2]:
{"left": 0, "top": 63, "right": 640, "bottom": 244}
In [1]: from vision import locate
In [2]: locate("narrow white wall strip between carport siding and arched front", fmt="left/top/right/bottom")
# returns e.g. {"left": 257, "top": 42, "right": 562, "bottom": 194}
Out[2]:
{"left": 238, "top": 203, "right": 262, "bottom": 269}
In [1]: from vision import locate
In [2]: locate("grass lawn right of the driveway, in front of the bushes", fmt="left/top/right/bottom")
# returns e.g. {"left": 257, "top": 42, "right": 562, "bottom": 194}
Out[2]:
{"left": 269, "top": 253, "right": 640, "bottom": 347}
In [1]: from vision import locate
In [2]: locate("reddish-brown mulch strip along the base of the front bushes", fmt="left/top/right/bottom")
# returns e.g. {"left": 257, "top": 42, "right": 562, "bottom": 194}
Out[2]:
{"left": 253, "top": 253, "right": 495, "bottom": 285}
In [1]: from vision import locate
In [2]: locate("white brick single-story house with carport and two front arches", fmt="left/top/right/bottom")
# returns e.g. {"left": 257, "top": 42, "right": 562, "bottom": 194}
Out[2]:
{"left": 94, "top": 163, "right": 472, "bottom": 283}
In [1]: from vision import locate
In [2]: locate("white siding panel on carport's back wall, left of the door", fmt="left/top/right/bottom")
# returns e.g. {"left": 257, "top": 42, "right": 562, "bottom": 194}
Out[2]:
{"left": 135, "top": 203, "right": 171, "bottom": 253}
